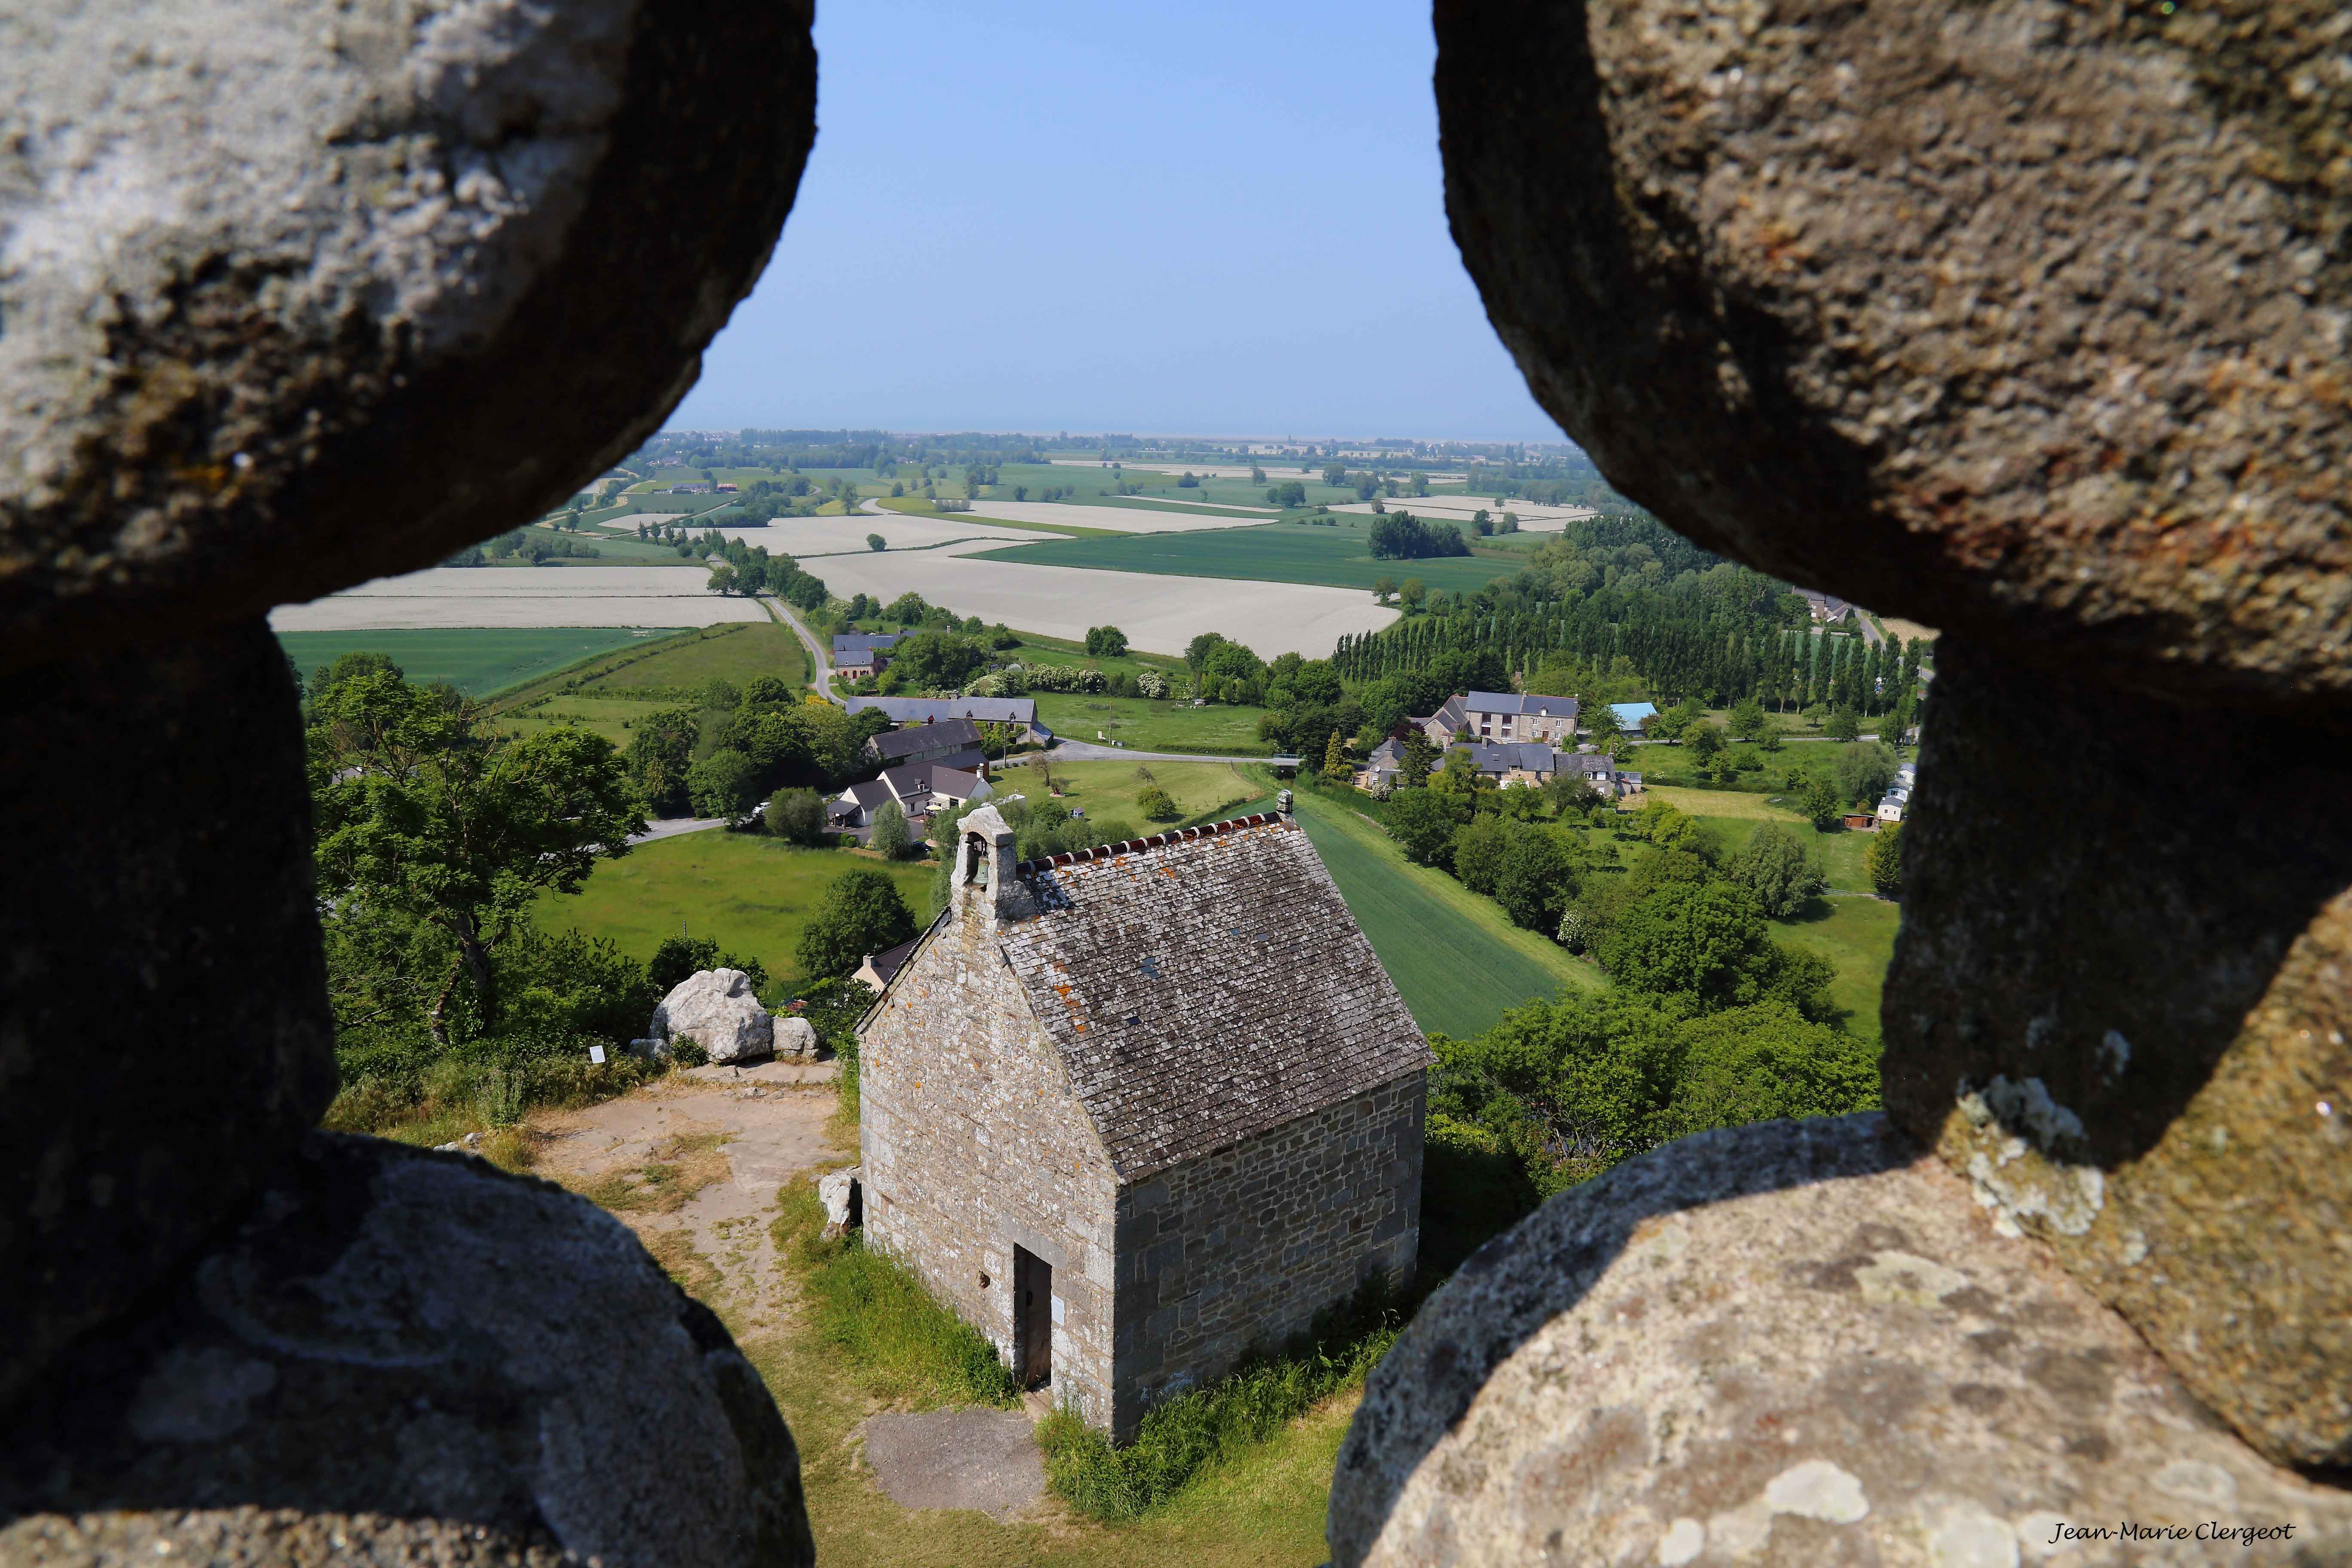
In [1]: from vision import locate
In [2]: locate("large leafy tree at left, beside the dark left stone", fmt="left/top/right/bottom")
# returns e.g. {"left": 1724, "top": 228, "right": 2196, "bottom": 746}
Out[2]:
{"left": 308, "top": 670, "right": 644, "bottom": 1044}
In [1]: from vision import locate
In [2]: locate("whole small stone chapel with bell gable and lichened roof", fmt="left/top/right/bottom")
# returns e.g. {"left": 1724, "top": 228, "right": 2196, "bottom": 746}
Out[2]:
{"left": 858, "top": 797, "right": 1432, "bottom": 1439}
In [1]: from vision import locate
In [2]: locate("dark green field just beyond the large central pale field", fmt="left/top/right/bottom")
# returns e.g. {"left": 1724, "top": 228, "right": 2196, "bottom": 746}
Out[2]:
{"left": 971, "top": 531, "right": 1517, "bottom": 592}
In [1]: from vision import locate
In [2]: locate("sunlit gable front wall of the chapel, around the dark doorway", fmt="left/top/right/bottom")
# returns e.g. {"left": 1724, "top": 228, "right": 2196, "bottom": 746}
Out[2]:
{"left": 858, "top": 888, "right": 1117, "bottom": 1424}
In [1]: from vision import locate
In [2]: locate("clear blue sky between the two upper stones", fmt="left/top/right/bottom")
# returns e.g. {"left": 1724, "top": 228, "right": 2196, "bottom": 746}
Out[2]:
{"left": 671, "top": 0, "right": 1562, "bottom": 440}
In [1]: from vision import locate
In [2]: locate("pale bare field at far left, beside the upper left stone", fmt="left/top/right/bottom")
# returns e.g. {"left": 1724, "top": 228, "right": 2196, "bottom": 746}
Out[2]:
{"left": 270, "top": 571, "right": 762, "bottom": 630}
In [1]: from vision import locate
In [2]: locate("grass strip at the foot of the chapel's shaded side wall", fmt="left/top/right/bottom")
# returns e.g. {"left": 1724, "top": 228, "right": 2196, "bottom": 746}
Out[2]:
{"left": 1037, "top": 1277, "right": 1402, "bottom": 1521}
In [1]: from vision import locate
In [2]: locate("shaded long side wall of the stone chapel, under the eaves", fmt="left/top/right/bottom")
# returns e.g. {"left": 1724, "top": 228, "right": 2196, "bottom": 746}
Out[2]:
{"left": 1112, "top": 1072, "right": 1428, "bottom": 1436}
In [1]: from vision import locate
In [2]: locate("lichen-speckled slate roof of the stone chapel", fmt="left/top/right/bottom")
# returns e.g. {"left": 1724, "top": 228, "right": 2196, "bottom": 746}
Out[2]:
{"left": 1002, "top": 816, "right": 1435, "bottom": 1180}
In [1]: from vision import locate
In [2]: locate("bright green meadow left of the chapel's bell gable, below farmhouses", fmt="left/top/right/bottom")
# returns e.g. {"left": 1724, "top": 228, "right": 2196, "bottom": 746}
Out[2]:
{"left": 532, "top": 827, "right": 931, "bottom": 980}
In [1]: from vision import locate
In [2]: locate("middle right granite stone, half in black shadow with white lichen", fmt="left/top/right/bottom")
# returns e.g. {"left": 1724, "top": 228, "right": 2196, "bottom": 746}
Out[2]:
{"left": 1884, "top": 637, "right": 2352, "bottom": 1464}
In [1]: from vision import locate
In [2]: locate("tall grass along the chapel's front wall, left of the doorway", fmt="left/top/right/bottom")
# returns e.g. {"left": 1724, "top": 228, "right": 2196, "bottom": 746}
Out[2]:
{"left": 769, "top": 1178, "right": 1021, "bottom": 1411}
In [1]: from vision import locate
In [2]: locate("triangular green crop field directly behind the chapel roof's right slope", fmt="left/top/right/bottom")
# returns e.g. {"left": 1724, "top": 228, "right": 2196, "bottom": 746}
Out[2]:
{"left": 1296, "top": 790, "right": 1602, "bottom": 1034}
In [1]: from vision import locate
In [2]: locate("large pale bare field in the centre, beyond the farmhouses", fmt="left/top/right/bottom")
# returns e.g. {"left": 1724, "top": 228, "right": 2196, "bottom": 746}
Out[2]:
{"left": 790, "top": 541, "right": 1397, "bottom": 658}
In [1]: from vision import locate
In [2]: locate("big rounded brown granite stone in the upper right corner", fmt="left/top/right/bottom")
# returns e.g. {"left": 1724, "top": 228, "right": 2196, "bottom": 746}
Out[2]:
{"left": 1437, "top": 0, "right": 2352, "bottom": 710}
